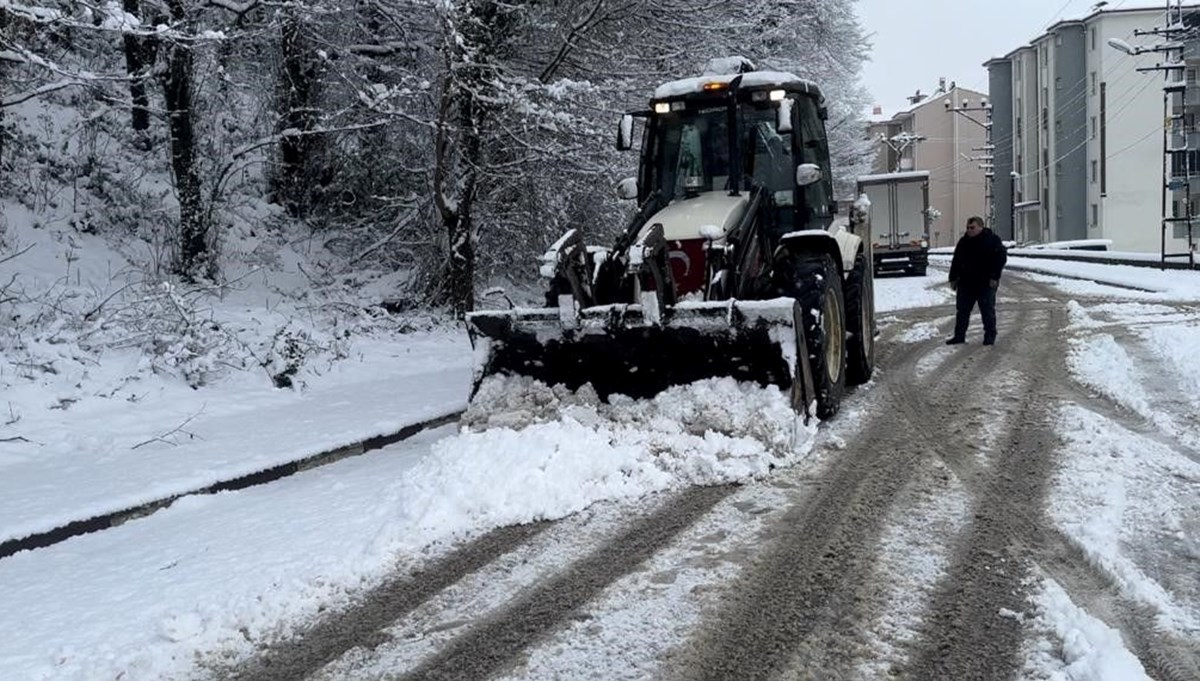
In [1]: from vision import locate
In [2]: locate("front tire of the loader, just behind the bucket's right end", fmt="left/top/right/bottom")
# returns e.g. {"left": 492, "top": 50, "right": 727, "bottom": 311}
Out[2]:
{"left": 781, "top": 252, "right": 846, "bottom": 420}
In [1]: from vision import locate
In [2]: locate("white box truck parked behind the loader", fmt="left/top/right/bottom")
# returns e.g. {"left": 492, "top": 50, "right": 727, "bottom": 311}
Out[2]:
{"left": 858, "top": 170, "right": 930, "bottom": 277}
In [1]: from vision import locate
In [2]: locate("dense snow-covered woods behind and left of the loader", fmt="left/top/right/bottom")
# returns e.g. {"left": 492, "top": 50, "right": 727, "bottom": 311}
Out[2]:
{"left": 0, "top": 0, "right": 871, "bottom": 313}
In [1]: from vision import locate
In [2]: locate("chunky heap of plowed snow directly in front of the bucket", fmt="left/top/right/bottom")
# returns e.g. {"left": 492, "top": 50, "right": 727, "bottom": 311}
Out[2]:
{"left": 396, "top": 376, "right": 816, "bottom": 534}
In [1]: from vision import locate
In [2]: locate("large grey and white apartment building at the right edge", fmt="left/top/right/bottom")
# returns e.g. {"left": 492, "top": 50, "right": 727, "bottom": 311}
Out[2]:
{"left": 984, "top": 6, "right": 1200, "bottom": 252}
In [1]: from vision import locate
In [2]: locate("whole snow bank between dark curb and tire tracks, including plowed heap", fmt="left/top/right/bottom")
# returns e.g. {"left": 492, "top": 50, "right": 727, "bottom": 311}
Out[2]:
{"left": 0, "top": 379, "right": 816, "bottom": 681}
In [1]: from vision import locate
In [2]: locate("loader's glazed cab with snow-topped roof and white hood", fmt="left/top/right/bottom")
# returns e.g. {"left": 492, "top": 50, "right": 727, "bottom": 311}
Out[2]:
{"left": 618, "top": 61, "right": 835, "bottom": 295}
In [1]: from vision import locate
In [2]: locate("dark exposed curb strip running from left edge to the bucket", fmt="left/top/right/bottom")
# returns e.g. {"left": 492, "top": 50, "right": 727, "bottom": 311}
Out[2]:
{"left": 0, "top": 410, "right": 463, "bottom": 559}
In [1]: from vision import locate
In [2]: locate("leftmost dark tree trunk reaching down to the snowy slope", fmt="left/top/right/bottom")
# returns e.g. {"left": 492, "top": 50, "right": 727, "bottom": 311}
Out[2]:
{"left": 162, "top": 44, "right": 207, "bottom": 279}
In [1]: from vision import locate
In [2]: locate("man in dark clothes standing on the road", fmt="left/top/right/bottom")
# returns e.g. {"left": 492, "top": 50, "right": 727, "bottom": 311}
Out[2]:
{"left": 946, "top": 217, "right": 1008, "bottom": 345}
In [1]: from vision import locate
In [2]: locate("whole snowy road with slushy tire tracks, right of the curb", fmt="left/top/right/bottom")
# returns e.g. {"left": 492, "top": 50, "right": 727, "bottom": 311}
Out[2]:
{"left": 0, "top": 271, "right": 1200, "bottom": 680}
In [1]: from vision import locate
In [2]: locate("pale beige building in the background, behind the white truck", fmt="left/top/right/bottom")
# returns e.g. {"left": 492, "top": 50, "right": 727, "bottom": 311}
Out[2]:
{"left": 869, "top": 85, "right": 988, "bottom": 247}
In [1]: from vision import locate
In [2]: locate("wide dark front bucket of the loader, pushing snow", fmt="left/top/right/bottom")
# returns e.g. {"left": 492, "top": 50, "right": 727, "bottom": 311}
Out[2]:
{"left": 467, "top": 299, "right": 815, "bottom": 418}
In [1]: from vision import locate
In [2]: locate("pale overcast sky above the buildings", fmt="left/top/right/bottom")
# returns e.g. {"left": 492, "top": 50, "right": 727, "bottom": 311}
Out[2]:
{"left": 858, "top": 0, "right": 1137, "bottom": 114}
